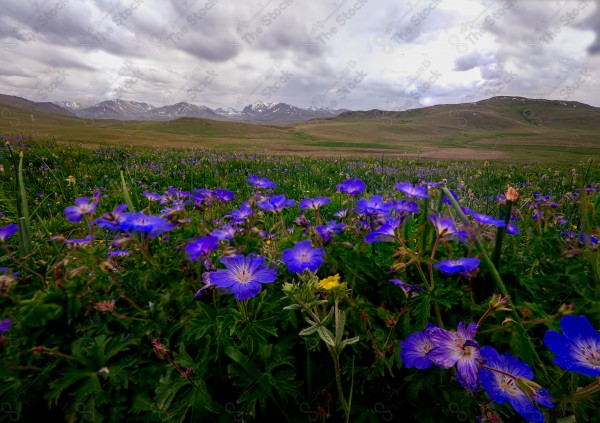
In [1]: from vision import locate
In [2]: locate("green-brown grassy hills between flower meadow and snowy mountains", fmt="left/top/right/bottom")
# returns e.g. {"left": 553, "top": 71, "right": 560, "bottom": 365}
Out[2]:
{"left": 0, "top": 98, "right": 600, "bottom": 161}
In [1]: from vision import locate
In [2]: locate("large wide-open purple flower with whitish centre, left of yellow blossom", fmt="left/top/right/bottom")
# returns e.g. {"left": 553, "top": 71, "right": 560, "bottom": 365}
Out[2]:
{"left": 210, "top": 253, "right": 277, "bottom": 300}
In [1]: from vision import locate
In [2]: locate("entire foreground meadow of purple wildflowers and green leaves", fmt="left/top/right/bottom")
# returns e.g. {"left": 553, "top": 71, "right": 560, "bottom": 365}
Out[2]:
{"left": 0, "top": 136, "right": 600, "bottom": 423}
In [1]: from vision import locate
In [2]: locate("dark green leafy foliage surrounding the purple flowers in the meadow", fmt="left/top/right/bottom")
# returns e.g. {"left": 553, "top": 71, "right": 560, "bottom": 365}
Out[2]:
{"left": 0, "top": 140, "right": 600, "bottom": 422}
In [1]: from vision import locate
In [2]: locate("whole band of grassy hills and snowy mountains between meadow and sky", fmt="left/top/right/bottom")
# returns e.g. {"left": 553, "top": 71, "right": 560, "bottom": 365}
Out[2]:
{"left": 0, "top": 95, "right": 600, "bottom": 162}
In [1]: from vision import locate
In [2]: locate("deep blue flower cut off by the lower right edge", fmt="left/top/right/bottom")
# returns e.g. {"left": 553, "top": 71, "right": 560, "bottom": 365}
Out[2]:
{"left": 544, "top": 315, "right": 600, "bottom": 377}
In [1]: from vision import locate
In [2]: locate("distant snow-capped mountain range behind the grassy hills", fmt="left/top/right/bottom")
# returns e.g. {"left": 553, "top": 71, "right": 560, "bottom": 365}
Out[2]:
{"left": 55, "top": 99, "right": 347, "bottom": 124}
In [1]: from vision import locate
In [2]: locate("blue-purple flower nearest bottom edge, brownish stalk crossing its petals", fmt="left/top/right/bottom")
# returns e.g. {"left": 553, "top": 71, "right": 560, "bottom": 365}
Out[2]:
{"left": 479, "top": 346, "right": 554, "bottom": 422}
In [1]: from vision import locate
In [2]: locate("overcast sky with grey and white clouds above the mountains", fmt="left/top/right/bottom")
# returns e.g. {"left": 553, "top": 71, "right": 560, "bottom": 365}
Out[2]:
{"left": 0, "top": 0, "right": 600, "bottom": 110}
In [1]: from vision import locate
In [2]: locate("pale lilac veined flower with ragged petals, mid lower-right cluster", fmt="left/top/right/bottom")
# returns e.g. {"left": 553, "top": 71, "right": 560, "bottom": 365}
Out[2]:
{"left": 425, "top": 322, "right": 480, "bottom": 391}
